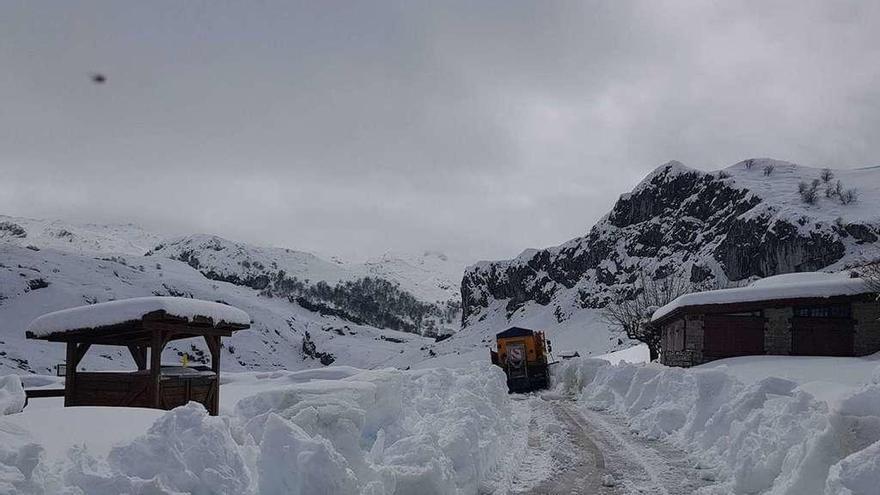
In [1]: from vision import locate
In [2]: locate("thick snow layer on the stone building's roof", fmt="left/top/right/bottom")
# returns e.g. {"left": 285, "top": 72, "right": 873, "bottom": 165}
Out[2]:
{"left": 651, "top": 272, "right": 872, "bottom": 321}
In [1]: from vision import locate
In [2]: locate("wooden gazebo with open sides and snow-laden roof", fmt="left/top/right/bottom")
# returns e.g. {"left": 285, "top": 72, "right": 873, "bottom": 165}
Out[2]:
{"left": 26, "top": 297, "right": 250, "bottom": 415}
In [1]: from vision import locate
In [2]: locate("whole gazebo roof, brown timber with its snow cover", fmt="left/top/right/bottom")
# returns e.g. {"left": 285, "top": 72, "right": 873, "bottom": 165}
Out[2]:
{"left": 25, "top": 297, "right": 251, "bottom": 345}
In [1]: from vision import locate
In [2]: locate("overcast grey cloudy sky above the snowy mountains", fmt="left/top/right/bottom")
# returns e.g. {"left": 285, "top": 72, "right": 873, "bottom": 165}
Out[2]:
{"left": 0, "top": 0, "right": 880, "bottom": 260}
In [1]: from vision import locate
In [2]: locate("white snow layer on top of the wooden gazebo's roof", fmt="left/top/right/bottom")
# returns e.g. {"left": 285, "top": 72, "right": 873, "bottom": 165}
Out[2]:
{"left": 26, "top": 297, "right": 251, "bottom": 337}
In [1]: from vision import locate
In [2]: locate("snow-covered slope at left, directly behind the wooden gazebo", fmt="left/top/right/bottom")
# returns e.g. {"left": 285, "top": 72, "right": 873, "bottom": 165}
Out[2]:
{"left": 0, "top": 243, "right": 433, "bottom": 373}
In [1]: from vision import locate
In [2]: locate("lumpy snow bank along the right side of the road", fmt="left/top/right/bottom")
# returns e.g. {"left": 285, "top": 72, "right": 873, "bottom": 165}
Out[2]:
{"left": 556, "top": 359, "right": 880, "bottom": 495}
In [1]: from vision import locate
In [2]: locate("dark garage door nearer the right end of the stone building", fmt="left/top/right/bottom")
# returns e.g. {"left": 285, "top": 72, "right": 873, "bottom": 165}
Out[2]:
{"left": 791, "top": 316, "right": 853, "bottom": 356}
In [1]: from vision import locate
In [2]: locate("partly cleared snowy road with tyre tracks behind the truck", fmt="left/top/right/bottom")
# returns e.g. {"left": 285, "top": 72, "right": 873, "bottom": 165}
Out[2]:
{"left": 495, "top": 396, "right": 710, "bottom": 495}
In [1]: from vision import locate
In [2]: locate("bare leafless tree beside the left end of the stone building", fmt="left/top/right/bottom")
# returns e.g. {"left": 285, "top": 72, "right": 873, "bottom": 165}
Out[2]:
{"left": 602, "top": 270, "right": 693, "bottom": 361}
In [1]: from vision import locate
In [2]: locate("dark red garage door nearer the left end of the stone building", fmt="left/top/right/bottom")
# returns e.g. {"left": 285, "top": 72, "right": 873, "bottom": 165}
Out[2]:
{"left": 703, "top": 315, "right": 764, "bottom": 359}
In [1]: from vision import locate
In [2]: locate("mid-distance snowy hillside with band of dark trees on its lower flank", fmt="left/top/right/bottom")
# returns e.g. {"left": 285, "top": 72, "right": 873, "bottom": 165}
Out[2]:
{"left": 147, "top": 235, "right": 460, "bottom": 335}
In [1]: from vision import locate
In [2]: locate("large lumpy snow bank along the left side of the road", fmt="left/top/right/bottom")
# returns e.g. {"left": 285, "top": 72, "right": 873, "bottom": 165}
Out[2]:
{"left": 0, "top": 365, "right": 513, "bottom": 495}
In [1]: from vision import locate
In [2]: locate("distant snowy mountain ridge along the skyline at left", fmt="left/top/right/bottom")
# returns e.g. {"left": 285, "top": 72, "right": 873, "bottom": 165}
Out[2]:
{"left": 0, "top": 215, "right": 469, "bottom": 312}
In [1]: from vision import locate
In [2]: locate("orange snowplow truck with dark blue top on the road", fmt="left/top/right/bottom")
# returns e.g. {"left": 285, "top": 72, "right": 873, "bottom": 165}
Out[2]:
{"left": 490, "top": 327, "right": 550, "bottom": 393}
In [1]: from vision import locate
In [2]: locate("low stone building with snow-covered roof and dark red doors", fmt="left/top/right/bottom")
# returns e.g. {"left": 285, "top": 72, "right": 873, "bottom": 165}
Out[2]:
{"left": 651, "top": 273, "right": 880, "bottom": 366}
